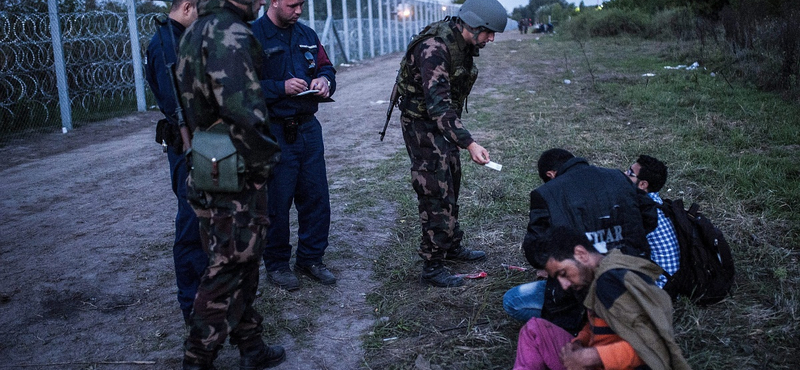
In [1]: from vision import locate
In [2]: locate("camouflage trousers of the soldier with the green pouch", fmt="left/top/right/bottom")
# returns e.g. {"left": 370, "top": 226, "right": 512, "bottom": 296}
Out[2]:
{"left": 184, "top": 176, "right": 269, "bottom": 364}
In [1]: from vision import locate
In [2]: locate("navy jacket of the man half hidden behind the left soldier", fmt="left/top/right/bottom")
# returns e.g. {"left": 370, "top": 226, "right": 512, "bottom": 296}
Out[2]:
{"left": 145, "top": 19, "right": 186, "bottom": 124}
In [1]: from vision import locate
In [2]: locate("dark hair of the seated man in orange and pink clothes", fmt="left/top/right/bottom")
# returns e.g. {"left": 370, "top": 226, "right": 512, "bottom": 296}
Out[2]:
{"left": 525, "top": 226, "right": 599, "bottom": 269}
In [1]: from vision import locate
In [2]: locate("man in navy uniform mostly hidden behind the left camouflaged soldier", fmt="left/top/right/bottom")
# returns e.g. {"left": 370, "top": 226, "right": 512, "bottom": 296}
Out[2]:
{"left": 145, "top": 0, "right": 208, "bottom": 325}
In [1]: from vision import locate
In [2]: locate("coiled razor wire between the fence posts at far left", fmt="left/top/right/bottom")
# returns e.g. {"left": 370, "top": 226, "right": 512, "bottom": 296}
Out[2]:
{"left": 0, "top": 11, "right": 158, "bottom": 128}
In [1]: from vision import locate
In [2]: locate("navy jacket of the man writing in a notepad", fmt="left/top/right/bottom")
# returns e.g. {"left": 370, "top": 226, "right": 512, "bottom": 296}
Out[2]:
{"left": 253, "top": 14, "right": 336, "bottom": 119}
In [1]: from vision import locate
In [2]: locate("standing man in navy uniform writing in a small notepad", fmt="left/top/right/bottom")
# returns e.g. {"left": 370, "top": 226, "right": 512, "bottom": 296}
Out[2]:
{"left": 253, "top": 0, "right": 336, "bottom": 291}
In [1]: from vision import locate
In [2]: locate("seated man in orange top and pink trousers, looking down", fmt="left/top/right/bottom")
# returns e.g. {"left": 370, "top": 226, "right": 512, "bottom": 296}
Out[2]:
{"left": 514, "top": 227, "right": 690, "bottom": 370}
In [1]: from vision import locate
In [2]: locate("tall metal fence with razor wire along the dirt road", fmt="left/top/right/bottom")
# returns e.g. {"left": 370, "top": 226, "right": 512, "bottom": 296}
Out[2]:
{"left": 0, "top": 0, "right": 478, "bottom": 138}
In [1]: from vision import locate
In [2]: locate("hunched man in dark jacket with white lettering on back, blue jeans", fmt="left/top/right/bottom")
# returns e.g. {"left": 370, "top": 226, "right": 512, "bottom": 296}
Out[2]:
{"left": 503, "top": 148, "right": 657, "bottom": 333}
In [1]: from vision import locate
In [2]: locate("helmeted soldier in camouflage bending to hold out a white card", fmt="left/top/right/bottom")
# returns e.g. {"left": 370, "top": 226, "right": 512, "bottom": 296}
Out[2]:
{"left": 397, "top": 0, "right": 507, "bottom": 287}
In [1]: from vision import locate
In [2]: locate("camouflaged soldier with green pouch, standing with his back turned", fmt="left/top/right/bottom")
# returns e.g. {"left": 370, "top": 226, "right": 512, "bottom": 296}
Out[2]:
{"left": 177, "top": 0, "right": 286, "bottom": 370}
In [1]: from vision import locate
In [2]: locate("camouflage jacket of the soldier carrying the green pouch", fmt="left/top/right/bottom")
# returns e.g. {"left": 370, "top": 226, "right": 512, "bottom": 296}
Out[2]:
{"left": 176, "top": 0, "right": 280, "bottom": 182}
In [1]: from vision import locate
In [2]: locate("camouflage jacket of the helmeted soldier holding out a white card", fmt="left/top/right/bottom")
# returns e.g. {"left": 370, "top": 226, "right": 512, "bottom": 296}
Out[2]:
{"left": 397, "top": 18, "right": 478, "bottom": 148}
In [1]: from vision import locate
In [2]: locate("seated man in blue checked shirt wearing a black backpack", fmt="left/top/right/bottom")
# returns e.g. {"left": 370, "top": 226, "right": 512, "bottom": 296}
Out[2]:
{"left": 625, "top": 154, "right": 681, "bottom": 288}
